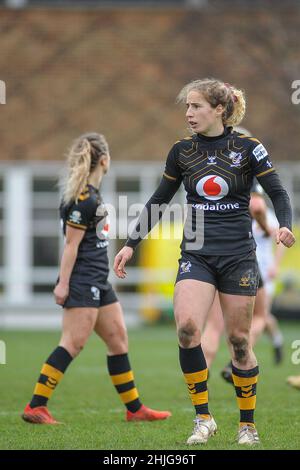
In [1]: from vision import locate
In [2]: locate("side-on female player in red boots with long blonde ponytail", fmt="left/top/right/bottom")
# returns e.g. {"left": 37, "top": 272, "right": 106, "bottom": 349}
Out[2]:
{"left": 22, "top": 133, "right": 171, "bottom": 424}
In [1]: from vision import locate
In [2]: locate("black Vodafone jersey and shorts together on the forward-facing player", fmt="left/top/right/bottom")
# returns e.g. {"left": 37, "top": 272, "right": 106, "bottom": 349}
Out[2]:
{"left": 126, "top": 127, "right": 291, "bottom": 295}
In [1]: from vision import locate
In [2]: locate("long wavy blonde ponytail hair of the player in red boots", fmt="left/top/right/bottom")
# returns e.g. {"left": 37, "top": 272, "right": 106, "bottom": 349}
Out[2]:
{"left": 62, "top": 132, "right": 109, "bottom": 205}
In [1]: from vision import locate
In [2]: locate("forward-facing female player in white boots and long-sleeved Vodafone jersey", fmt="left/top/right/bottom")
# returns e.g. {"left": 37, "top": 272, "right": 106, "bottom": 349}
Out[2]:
{"left": 114, "top": 79, "right": 295, "bottom": 445}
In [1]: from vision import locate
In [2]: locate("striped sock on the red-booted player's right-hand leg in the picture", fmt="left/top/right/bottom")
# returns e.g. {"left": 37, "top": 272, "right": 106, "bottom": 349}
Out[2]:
{"left": 107, "top": 354, "right": 142, "bottom": 413}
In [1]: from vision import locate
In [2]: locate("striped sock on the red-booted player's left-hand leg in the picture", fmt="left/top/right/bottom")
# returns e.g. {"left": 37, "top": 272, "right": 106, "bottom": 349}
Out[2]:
{"left": 30, "top": 346, "right": 73, "bottom": 408}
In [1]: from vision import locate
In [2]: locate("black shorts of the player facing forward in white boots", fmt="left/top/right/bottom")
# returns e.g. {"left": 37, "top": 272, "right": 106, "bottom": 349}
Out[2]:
{"left": 176, "top": 250, "right": 259, "bottom": 296}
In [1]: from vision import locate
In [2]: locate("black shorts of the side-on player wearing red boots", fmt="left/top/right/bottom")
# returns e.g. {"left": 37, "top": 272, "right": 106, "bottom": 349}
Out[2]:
{"left": 63, "top": 280, "right": 118, "bottom": 308}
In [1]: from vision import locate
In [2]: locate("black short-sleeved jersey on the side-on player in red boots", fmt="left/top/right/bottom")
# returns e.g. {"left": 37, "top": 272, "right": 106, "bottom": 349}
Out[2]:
{"left": 60, "top": 185, "right": 109, "bottom": 286}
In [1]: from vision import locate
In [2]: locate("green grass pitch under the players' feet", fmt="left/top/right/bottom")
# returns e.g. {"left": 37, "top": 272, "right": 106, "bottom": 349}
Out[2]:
{"left": 0, "top": 323, "right": 300, "bottom": 450}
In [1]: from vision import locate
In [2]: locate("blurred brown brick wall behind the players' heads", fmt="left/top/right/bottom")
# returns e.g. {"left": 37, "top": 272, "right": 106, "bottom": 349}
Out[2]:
{"left": 0, "top": 7, "right": 300, "bottom": 160}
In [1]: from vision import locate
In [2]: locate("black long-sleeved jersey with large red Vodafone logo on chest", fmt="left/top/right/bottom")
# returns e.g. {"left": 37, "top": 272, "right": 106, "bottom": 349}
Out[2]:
{"left": 126, "top": 128, "right": 291, "bottom": 255}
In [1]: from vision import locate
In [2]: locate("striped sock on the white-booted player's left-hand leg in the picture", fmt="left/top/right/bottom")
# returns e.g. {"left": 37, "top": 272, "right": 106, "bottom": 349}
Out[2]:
{"left": 179, "top": 344, "right": 210, "bottom": 415}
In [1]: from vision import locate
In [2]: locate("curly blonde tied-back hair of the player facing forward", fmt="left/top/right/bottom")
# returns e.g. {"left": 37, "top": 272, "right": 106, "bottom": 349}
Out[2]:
{"left": 176, "top": 78, "right": 246, "bottom": 126}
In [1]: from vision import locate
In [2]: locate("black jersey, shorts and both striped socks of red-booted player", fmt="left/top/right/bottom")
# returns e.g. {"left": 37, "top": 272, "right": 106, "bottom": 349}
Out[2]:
{"left": 28, "top": 185, "right": 142, "bottom": 412}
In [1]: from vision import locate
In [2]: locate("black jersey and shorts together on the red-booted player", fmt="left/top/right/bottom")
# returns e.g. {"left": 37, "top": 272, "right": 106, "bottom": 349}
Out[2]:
{"left": 60, "top": 185, "right": 117, "bottom": 308}
